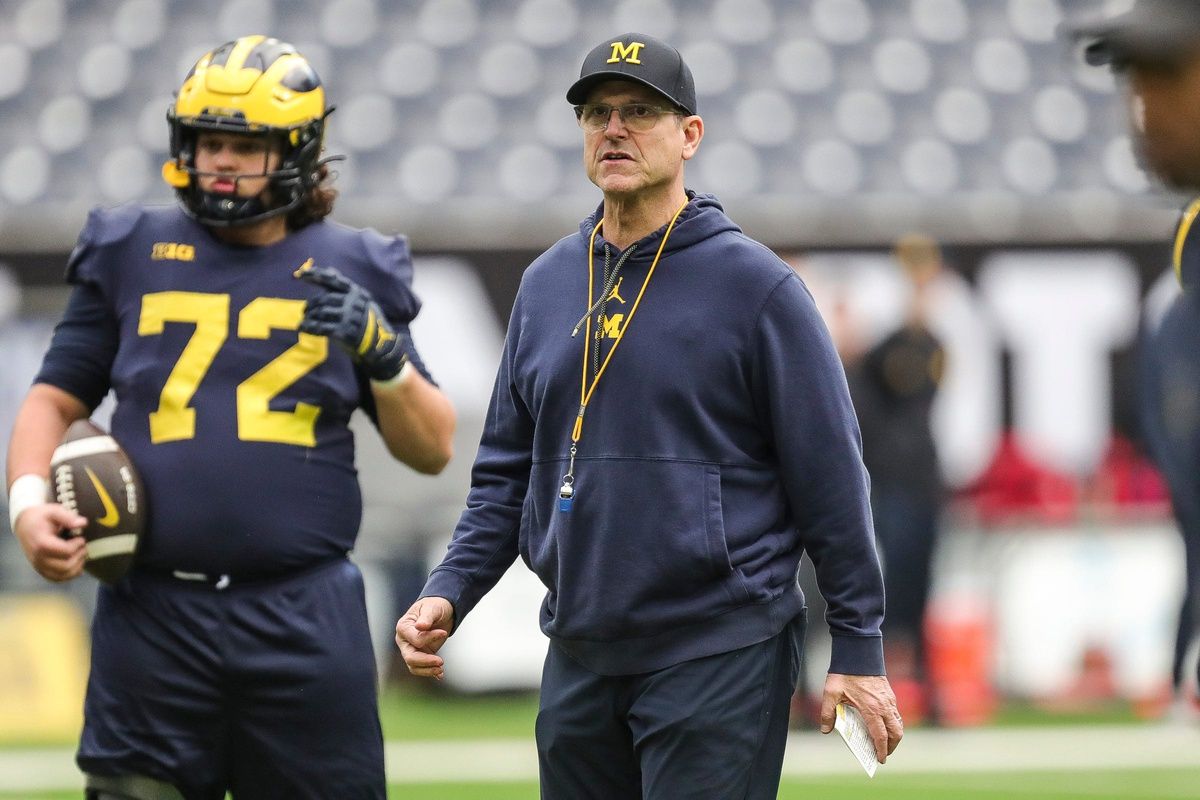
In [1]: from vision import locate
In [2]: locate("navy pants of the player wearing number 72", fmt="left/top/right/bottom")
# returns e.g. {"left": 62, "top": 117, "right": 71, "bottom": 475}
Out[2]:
{"left": 77, "top": 560, "right": 386, "bottom": 800}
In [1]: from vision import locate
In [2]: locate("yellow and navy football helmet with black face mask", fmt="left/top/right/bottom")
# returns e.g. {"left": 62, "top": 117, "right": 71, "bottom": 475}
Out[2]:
{"left": 162, "top": 36, "right": 334, "bottom": 227}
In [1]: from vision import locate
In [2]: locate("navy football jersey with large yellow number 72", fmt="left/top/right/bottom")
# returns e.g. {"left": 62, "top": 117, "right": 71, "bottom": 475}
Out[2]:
{"left": 40, "top": 206, "right": 420, "bottom": 576}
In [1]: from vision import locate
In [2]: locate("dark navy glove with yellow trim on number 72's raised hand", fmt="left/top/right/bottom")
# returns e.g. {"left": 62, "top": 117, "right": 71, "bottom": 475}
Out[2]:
{"left": 293, "top": 258, "right": 408, "bottom": 380}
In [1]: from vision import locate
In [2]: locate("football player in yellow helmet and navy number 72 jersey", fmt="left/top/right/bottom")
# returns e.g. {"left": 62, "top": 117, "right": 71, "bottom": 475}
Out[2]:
{"left": 8, "top": 36, "right": 455, "bottom": 800}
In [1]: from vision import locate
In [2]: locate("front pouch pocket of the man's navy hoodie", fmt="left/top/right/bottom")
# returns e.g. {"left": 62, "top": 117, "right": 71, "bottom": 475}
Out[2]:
{"left": 520, "top": 459, "right": 749, "bottom": 639}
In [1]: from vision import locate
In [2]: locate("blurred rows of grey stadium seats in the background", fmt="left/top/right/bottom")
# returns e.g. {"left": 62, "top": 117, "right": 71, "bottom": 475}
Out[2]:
{"left": 0, "top": 0, "right": 1160, "bottom": 245}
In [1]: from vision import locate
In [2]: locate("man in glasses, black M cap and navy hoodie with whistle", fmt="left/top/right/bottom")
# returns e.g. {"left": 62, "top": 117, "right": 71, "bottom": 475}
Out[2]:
{"left": 396, "top": 34, "right": 902, "bottom": 800}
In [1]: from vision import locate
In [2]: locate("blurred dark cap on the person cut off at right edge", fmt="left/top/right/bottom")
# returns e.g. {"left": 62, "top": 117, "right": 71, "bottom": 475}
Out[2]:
{"left": 1072, "top": 0, "right": 1200, "bottom": 66}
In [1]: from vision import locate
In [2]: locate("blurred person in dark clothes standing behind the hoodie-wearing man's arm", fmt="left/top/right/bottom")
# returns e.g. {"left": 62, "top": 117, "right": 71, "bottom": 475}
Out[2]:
{"left": 847, "top": 233, "right": 946, "bottom": 722}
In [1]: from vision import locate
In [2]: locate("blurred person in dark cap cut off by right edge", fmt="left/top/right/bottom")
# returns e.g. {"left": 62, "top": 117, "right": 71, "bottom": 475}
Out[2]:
{"left": 1073, "top": 0, "right": 1200, "bottom": 718}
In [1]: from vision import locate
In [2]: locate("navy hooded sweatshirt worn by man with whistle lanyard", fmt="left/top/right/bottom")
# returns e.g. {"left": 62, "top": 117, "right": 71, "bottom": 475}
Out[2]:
{"left": 421, "top": 193, "right": 883, "bottom": 675}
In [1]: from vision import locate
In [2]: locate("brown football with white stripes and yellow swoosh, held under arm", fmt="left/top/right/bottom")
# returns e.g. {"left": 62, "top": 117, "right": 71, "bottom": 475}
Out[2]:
{"left": 50, "top": 420, "right": 146, "bottom": 583}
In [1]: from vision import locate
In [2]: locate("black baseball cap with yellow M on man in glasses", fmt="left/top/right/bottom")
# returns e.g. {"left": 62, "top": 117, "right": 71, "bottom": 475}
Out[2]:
{"left": 566, "top": 34, "right": 696, "bottom": 114}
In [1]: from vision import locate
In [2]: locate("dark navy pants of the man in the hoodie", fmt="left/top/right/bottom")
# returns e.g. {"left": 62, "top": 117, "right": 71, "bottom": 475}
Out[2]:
{"left": 536, "top": 614, "right": 804, "bottom": 800}
